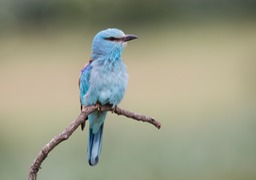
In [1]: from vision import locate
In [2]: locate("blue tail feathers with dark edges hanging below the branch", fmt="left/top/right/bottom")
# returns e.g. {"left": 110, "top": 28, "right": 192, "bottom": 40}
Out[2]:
{"left": 88, "top": 123, "right": 104, "bottom": 166}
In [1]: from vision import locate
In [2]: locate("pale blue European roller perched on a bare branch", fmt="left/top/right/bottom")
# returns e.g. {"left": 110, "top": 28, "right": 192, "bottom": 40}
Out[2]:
{"left": 79, "top": 29, "right": 137, "bottom": 166}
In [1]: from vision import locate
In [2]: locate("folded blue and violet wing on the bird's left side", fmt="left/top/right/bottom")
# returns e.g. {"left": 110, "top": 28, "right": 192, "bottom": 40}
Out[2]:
{"left": 78, "top": 59, "right": 92, "bottom": 130}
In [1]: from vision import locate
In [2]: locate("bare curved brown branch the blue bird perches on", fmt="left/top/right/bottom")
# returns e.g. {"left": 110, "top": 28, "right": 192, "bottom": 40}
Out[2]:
{"left": 28, "top": 105, "right": 161, "bottom": 180}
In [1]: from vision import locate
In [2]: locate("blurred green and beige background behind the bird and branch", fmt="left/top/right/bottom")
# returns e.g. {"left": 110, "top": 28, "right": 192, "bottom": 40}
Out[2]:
{"left": 0, "top": 0, "right": 256, "bottom": 180}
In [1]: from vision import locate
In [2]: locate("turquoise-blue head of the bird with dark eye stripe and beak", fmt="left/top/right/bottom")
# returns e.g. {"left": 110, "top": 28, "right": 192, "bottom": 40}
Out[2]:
{"left": 92, "top": 29, "right": 138, "bottom": 58}
